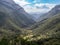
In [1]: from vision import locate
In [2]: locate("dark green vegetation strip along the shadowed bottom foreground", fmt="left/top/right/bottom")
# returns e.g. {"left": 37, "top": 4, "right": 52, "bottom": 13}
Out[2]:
{"left": 0, "top": 36, "right": 60, "bottom": 45}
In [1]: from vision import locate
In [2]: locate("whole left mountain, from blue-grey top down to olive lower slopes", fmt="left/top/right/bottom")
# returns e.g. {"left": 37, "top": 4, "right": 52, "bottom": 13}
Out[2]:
{"left": 0, "top": 0, "right": 35, "bottom": 36}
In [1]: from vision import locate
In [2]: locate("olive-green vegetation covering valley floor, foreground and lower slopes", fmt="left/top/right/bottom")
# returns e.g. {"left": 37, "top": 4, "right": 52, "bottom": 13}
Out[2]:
{"left": 0, "top": 14, "right": 60, "bottom": 45}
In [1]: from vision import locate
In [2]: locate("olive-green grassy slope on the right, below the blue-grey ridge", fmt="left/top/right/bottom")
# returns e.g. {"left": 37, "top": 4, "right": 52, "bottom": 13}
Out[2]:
{"left": 33, "top": 14, "right": 60, "bottom": 37}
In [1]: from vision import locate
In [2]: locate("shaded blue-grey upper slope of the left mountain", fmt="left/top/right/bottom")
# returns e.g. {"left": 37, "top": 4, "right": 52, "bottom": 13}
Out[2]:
{"left": 0, "top": 0, "right": 34, "bottom": 27}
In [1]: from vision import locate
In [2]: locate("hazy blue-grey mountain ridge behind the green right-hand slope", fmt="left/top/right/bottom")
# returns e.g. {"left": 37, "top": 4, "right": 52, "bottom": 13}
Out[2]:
{"left": 38, "top": 5, "right": 60, "bottom": 21}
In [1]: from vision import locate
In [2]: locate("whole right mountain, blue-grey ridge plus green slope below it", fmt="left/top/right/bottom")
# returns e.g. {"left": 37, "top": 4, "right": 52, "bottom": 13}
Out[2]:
{"left": 33, "top": 5, "right": 60, "bottom": 38}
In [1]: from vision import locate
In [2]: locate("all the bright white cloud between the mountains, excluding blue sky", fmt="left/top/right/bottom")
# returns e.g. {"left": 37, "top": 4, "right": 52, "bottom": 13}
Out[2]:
{"left": 14, "top": 0, "right": 56, "bottom": 13}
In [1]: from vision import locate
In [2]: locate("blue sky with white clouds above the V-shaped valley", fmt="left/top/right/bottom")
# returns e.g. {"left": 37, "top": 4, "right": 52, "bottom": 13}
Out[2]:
{"left": 14, "top": 0, "right": 60, "bottom": 13}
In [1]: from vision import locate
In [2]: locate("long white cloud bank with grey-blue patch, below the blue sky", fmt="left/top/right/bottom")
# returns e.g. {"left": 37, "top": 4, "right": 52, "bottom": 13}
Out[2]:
{"left": 24, "top": 3, "right": 55, "bottom": 13}
